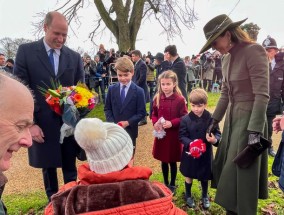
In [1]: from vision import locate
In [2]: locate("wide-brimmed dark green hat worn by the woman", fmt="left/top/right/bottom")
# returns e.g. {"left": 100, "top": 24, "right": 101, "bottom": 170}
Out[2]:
{"left": 199, "top": 14, "right": 247, "bottom": 53}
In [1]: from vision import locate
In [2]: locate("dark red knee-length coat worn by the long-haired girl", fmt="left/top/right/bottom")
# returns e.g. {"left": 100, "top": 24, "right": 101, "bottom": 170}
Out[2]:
{"left": 152, "top": 93, "right": 188, "bottom": 163}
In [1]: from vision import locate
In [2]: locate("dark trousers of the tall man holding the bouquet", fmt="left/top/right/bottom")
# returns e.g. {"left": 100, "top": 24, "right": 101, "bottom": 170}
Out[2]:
{"left": 42, "top": 136, "right": 79, "bottom": 201}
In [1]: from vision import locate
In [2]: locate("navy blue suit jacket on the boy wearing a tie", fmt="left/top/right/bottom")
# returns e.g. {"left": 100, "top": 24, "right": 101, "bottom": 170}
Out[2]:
{"left": 104, "top": 82, "right": 146, "bottom": 139}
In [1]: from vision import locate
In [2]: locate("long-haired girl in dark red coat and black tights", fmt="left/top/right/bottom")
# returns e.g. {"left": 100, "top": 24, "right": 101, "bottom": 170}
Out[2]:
{"left": 152, "top": 70, "right": 187, "bottom": 193}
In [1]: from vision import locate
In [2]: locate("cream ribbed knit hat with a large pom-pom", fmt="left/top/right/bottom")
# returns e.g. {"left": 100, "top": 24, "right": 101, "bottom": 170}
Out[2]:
{"left": 74, "top": 118, "right": 133, "bottom": 174}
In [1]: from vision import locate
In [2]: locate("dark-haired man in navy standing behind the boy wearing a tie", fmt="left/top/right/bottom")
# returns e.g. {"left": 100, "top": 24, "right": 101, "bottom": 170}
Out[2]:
{"left": 131, "top": 50, "right": 150, "bottom": 126}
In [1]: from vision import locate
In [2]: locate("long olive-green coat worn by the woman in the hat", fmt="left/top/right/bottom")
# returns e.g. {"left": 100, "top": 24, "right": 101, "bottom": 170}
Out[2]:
{"left": 212, "top": 43, "right": 269, "bottom": 215}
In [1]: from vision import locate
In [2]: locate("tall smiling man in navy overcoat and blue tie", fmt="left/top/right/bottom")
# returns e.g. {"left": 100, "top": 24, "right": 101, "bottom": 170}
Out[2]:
{"left": 14, "top": 11, "right": 84, "bottom": 200}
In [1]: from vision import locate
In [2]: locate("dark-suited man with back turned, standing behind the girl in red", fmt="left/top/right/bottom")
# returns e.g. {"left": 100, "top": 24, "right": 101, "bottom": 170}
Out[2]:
{"left": 164, "top": 45, "right": 188, "bottom": 102}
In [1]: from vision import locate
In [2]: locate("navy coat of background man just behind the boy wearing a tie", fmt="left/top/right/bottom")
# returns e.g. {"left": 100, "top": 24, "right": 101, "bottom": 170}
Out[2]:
{"left": 132, "top": 59, "right": 150, "bottom": 103}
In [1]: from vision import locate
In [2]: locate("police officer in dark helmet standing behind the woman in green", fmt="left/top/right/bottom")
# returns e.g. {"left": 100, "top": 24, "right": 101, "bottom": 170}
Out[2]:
{"left": 262, "top": 36, "right": 284, "bottom": 157}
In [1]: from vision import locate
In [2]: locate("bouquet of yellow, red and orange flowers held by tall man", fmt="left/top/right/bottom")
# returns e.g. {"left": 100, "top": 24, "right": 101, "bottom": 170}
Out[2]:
{"left": 38, "top": 80, "right": 98, "bottom": 142}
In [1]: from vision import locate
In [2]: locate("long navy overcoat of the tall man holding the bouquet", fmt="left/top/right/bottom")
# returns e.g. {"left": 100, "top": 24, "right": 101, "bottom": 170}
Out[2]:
{"left": 14, "top": 39, "right": 84, "bottom": 168}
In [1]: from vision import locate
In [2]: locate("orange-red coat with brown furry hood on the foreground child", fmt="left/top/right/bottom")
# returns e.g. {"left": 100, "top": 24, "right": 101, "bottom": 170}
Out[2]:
{"left": 44, "top": 164, "right": 186, "bottom": 215}
